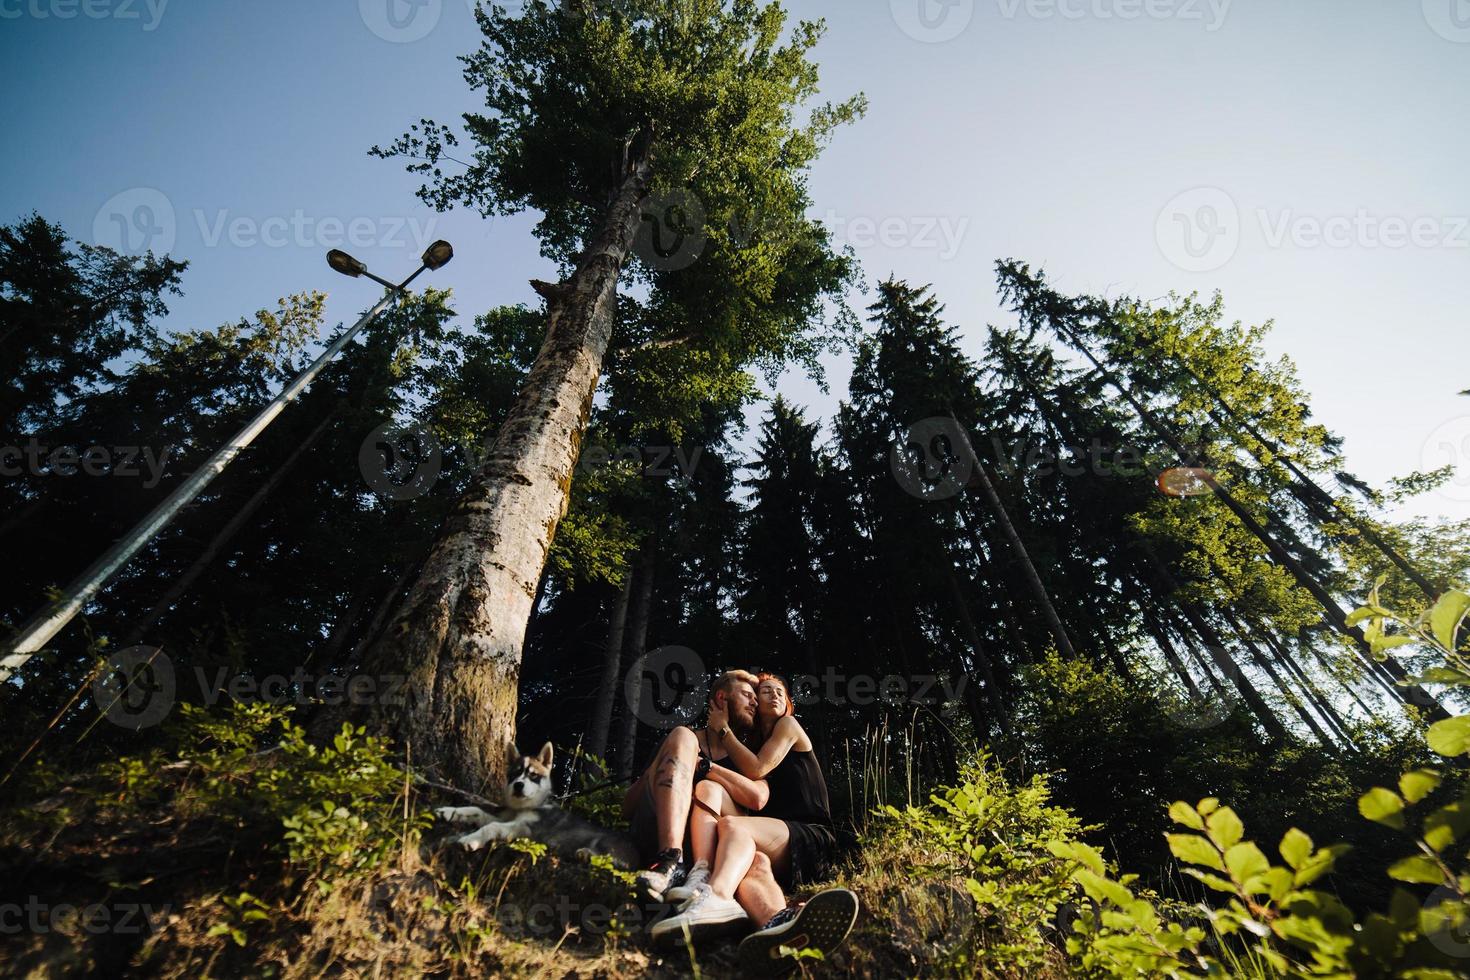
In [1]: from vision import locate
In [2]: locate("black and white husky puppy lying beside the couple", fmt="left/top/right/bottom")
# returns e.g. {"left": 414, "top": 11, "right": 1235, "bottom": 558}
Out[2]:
{"left": 434, "top": 742, "right": 638, "bottom": 868}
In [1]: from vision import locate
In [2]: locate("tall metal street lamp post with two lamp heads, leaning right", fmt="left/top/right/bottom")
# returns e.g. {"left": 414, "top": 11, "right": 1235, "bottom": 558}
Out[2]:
{"left": 0, "top": 241, "right": 454, "bottom": 683}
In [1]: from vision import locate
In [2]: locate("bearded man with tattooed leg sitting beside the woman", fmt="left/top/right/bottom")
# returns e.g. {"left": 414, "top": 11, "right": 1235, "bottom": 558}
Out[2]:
{"left": 623, "top": 670, "right": 769, "bottom": 902}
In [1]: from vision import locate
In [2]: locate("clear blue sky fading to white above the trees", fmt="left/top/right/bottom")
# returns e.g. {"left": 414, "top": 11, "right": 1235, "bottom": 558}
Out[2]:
{"left": 0, "top": 0, "right": 1470, "bottom": 517}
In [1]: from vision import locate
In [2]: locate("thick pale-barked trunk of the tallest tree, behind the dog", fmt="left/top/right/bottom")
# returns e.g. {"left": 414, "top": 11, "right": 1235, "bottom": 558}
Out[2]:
{"left": 345, "top": 147, "right": 651, "bottom": 789}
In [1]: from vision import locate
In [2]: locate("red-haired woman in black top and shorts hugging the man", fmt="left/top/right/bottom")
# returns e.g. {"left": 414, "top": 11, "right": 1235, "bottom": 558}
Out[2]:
{"left": 653, "top": 674, "right": 857, "bottom": 956}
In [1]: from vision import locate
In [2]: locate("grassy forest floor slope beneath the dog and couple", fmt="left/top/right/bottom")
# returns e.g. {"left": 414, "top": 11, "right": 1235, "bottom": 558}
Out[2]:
{"left": 0, "top": 792, "right": 1034, "bottom": 980}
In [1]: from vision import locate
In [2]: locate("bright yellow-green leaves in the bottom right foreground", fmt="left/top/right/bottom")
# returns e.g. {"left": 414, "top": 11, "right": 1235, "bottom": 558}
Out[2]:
{"left": 1054, "top": 578, "right": 1470, "bottom": 980}
